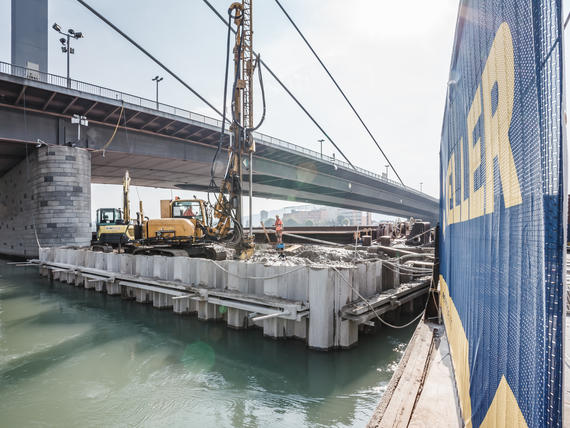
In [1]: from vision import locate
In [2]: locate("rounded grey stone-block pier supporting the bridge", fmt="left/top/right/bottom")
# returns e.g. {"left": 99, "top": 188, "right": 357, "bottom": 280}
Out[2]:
{"left": 0, "top": 146, "right": 91, "bottom": 257}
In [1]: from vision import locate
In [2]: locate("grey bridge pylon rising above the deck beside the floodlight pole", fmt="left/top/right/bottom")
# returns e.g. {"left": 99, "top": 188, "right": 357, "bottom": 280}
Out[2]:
{"left": 11, "top": 0, "right": 47, "bottom": 72}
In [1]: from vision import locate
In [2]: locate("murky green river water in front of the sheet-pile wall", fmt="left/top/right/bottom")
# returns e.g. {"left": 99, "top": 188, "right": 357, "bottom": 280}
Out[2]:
{"left": 0, "top": 261, "right": 413, "bottom": 428}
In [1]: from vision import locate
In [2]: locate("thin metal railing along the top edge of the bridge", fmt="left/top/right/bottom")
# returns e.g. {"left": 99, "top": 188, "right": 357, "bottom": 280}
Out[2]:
{"left": 0, "top": 61, "right": 428, "bottom": 201}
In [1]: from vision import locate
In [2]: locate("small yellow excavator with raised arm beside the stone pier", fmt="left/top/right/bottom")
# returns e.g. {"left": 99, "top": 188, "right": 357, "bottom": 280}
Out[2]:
{"left": 92, "top": 171, "right": 142, "bottom": 250}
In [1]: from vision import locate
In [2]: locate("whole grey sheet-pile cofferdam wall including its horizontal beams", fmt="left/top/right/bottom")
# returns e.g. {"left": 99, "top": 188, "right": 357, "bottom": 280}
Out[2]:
{"left": 37, "top": 248, "right": 427, "bottom": 350}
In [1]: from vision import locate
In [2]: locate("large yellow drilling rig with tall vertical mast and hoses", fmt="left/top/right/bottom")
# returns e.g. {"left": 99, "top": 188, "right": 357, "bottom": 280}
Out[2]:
{"left": 127, "top": 0, "right": 265, "bottom": 260}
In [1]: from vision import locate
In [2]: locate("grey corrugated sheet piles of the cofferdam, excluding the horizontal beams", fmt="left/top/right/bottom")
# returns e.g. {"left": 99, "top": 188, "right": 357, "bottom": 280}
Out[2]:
{"left": 40, "top": 248, "right": 382, "bottom": 350}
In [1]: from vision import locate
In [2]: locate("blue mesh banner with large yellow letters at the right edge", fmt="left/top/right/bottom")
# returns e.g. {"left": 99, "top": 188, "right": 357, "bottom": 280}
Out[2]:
{"left": 439, "top": 0, "right": 567, "bottom": 427}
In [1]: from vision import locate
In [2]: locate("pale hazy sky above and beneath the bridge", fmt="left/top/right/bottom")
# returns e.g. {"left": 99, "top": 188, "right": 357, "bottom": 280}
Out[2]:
{"left": 0, "top": 0, "right": 564, "bottom": 221}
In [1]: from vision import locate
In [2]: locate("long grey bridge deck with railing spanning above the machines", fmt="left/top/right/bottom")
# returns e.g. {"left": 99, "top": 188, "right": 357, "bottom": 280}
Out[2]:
{"left": 0, "top": 62, "right": 438, "bottom": 251}
